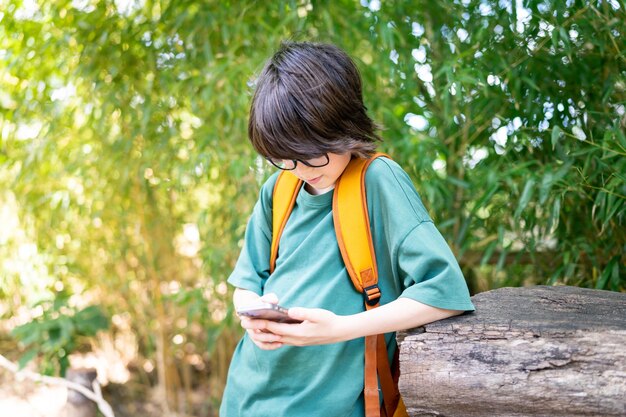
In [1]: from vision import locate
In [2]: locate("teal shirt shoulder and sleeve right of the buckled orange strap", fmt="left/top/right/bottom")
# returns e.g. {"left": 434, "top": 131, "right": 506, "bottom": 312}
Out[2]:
{"left": 366, "top": 158, "right": 474, "bottom": 311}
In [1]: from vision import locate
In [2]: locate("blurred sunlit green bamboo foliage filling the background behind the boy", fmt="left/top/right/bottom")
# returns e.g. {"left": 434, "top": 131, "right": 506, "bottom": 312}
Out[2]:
{"left": 0, "top": 0, "right": 626, "bottom": 407}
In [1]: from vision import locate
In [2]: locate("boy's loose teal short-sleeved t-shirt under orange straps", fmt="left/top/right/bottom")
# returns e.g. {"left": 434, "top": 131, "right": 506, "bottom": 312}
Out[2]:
{"left": 220, "top": 158, "right": 474, "bottom": 417}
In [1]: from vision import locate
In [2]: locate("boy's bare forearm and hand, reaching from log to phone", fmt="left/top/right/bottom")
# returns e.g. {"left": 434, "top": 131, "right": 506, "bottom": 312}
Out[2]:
{"left": 251, "top": 297, "right": 463, "bottom": 346}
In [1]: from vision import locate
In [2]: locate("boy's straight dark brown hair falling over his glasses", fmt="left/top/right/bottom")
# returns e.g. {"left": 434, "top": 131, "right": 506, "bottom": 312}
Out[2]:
{"left": 248, "top": 42, "right": 381, "bottom": 159}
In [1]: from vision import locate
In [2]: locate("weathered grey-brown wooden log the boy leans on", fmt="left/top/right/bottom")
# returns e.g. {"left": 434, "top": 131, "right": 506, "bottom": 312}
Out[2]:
{"left": 398, "top": 286, "right": 626, "bottom": 417}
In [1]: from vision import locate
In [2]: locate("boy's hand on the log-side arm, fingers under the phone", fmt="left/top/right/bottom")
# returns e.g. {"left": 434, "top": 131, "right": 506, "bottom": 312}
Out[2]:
{"left": 265, "top": 307, "right": 351, "bottom": 346}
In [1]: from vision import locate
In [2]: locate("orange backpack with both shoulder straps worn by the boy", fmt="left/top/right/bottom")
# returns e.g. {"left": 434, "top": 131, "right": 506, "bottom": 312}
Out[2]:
{"left": 270, "top": 153, "right": 408, "bottom": 417}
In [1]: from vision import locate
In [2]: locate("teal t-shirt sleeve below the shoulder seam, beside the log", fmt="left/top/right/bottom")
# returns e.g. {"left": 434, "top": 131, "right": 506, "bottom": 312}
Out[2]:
{"left": 396, "top": 221, "right": 474, "bottom": 311}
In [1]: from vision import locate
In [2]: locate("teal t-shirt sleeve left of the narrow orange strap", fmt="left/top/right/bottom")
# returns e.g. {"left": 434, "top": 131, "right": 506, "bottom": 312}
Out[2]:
{"left": 223, "top": 175, "right": 277, "bottom": 295}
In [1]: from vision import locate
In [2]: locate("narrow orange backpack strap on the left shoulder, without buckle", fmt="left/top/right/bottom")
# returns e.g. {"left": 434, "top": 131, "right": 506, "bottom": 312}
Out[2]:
{"left": 270, "top": 171, "right": 302, "bottom": 273}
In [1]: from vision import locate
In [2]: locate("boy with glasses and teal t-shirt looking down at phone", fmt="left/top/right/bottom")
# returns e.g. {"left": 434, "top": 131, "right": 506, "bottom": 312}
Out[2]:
{"left": 220, "top": 42, "right": 474, "bottom": 417}
